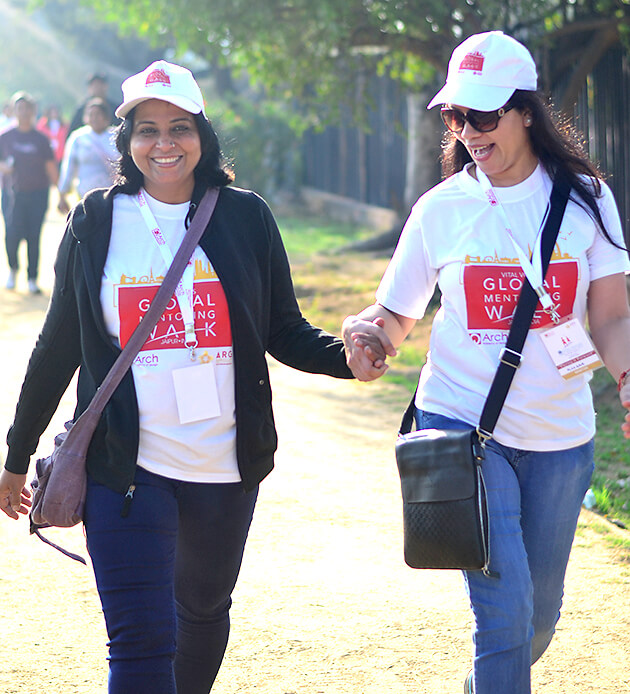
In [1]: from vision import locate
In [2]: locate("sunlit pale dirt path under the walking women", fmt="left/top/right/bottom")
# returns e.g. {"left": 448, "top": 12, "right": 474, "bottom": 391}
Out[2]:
{"left": 0, "top": 216, "right": 630, "bottom": 694}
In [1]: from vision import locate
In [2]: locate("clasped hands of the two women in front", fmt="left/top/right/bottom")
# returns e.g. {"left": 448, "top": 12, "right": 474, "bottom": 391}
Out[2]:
{"left": 341, "top": 316, "right": 396, "bottom": 381}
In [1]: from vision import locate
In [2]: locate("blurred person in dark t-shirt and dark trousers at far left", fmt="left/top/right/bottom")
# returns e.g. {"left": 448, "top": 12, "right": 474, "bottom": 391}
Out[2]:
{"left": 0, "top": 92, "right": 58, "bottom": 294}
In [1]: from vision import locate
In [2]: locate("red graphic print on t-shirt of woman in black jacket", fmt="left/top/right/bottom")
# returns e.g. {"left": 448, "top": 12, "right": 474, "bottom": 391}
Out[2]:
{"left": 118, "top": 280, "right": 232, "bottom": 351}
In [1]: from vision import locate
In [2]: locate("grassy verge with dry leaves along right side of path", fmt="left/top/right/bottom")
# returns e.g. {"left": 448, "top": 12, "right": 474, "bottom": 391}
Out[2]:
{"left": 278, "top": 214, "right": 630, "bottom": 527}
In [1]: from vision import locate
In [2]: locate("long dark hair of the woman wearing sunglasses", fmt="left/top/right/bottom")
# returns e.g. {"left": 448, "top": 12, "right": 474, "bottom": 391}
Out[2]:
{"left": 441, "top": 89, "right": 626, "bottom": 250}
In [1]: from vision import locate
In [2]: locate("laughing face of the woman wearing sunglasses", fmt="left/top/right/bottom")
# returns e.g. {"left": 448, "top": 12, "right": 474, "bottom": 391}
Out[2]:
{"left": 456, "top": 106, "right": 538, "bottom": 187}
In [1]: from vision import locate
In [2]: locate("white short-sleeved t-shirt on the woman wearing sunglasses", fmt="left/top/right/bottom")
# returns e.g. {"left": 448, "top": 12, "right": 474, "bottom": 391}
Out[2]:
{"left": 376, "top": 166, "right": 630, "bottom": 451}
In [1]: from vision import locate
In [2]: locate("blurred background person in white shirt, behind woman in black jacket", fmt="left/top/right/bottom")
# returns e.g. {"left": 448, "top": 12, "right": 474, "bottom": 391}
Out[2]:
{"left": 58, "top": 97, "right": 120, "bottom": 214}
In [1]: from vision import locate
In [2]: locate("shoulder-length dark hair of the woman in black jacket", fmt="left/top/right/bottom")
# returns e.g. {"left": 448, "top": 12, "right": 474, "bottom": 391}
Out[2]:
{"left": 115, "top": 108, "right": 234, "bottom": 194}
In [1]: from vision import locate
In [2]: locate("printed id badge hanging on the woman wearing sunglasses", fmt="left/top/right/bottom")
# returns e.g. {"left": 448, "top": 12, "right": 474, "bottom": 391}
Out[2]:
{"left": 540, "top": 317, "right": 604, "bottom": 379}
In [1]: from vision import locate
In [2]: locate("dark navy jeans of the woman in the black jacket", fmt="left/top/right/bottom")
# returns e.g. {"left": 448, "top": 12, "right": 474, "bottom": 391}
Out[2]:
{"left": 84, "top": 468, "right": 258, "bottom": 694}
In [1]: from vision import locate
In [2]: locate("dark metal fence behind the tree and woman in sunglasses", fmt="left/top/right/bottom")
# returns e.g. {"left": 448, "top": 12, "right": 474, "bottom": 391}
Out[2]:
{"left": 303, "top": 47, "right": 630, "bottom": 247}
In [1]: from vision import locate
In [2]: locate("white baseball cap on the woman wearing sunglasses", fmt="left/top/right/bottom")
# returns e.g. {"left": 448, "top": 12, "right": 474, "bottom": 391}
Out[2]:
{"left": 427, "top": 31, "right": 538, "bottom": 111}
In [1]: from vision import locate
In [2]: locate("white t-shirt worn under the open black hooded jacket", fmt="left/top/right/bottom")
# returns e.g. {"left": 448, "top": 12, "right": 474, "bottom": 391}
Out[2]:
{"left": 101, "top": 192, "right": 240, "bottom": 483}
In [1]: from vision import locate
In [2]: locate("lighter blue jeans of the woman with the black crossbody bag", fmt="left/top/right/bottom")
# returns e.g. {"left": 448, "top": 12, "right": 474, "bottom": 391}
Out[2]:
{"left": 416, "top": 411, "right": 593, "bottom": 694}
